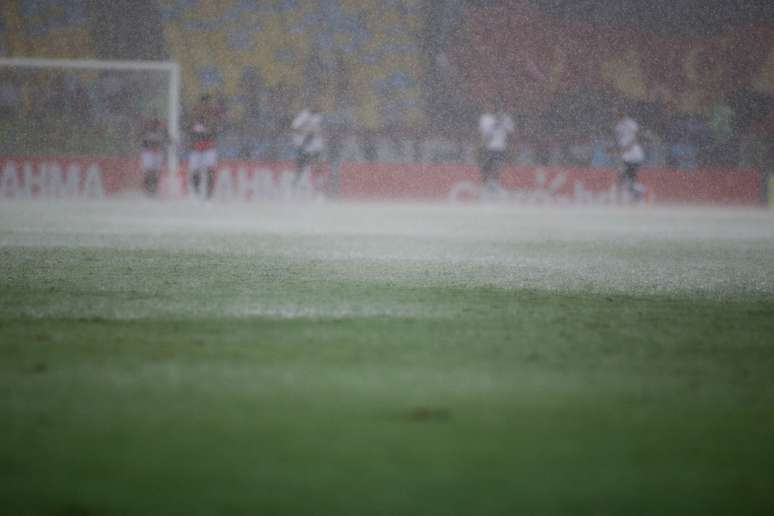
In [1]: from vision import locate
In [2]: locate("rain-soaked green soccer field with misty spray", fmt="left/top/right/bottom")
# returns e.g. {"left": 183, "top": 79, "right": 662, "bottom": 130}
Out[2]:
{"left": 0, "top": 199, "right": 774, "bottom": 516}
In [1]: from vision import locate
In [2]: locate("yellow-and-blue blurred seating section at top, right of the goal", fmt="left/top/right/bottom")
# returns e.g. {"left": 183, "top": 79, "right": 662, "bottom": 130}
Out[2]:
{"left": 159, "top": 0, "right": 421, "bottom": 128}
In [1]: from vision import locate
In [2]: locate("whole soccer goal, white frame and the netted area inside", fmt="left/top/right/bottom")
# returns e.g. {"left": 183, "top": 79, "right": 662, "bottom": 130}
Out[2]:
{"left": 0, "top": 58, "right": 180, "bottom": 198}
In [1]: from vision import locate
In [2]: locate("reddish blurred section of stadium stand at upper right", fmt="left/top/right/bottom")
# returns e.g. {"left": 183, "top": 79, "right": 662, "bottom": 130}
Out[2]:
{"left": 452, "top": 2, "right": 774, "bottom": 168}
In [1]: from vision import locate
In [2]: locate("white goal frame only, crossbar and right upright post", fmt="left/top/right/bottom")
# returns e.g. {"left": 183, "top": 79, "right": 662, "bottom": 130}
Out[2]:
{"left": 0, "top": 57, "right": 181, "bottom": 195}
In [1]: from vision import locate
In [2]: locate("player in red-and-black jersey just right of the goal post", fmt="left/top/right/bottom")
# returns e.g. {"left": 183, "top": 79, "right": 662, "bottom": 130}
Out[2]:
{"left": 188, "top": 95, "right": 222, "bottom": 199}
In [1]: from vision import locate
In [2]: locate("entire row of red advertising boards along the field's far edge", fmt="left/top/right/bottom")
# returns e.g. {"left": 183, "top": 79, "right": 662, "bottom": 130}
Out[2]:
{"left": 0, "top": 157, "right": 765, "bottom": 205}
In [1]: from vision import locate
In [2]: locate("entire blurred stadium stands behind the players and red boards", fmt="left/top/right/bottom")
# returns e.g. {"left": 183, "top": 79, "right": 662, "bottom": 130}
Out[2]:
{"left": 0, "top": 0, "right": 774, "bottom": 170}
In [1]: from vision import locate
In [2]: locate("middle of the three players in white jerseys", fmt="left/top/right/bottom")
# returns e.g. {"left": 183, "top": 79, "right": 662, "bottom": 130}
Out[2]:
{"left": 478, "top": 102, "right": 514, "bottom": 195}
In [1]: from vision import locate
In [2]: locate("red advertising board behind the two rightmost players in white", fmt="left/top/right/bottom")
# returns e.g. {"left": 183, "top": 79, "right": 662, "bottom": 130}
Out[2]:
{"left": 339, "top": 163, "right": 762, "bottom": 205}
